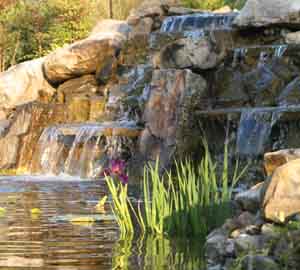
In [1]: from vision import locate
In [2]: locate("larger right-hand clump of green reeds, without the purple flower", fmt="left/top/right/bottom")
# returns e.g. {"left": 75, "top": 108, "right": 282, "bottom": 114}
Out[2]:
{"left": 139, "top": 140, "right": 247, "bottom": 236}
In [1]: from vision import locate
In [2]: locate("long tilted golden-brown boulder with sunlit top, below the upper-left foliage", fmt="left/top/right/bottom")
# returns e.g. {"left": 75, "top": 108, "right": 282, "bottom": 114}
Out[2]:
{"left": 44, "top": 20, "right": 130, "bottom": 84}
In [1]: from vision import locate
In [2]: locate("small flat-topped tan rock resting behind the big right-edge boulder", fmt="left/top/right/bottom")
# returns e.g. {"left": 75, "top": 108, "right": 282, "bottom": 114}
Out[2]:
{"left": 264, "top": 149, "right": 300, "bottom": 176}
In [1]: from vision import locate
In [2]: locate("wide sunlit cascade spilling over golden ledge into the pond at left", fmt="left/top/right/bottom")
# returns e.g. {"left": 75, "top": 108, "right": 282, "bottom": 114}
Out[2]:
{"left": 31, "top": 121, "right": 139, "bottom": 177}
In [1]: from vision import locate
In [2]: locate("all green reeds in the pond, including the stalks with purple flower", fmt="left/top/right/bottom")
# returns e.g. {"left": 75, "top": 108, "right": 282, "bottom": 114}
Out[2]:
{"left": 105, "top": 141, "right": 247, "bottom": 236}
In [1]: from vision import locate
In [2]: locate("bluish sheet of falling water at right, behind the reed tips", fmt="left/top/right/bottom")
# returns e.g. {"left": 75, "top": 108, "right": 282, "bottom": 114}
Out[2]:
{"left": 237, "top": 109, "right": 281, "bottom": 156}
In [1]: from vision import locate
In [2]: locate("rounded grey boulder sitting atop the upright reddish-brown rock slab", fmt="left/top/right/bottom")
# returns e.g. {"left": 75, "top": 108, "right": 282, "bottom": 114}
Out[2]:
{"left": 154, "top": 38, "right": 225, "bottom": 70}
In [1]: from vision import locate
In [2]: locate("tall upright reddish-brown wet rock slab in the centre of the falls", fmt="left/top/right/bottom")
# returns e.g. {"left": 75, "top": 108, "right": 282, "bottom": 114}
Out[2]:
{"left": 141, "top": 70, "right": 207, "bottom": 165}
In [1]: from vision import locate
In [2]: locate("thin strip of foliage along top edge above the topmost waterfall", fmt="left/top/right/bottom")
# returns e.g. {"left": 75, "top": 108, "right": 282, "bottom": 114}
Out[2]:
{"left": 182, "top": 0, "right": 246, "bottom": 10}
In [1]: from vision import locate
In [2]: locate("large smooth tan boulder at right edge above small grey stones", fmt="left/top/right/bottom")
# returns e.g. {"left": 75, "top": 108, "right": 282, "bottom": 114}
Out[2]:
{"left": 263, "top": 159, "right": 300, "bottom": 223}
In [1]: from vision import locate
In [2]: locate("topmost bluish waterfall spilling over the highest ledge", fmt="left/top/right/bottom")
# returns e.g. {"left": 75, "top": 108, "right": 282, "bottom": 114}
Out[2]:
{"left": 161, "top": 13, "right": 237, "bottom": 32}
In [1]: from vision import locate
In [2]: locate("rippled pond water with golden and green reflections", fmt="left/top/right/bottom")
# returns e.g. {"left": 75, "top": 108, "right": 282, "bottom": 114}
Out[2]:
{"left": 0, "top": 176, "right": 204, "bottom": 270}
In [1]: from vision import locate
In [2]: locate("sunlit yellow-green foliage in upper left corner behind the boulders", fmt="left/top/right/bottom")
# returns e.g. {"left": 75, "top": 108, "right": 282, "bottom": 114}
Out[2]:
{"left": 0, "top": 0, "right": 141, "bottom": 71}
